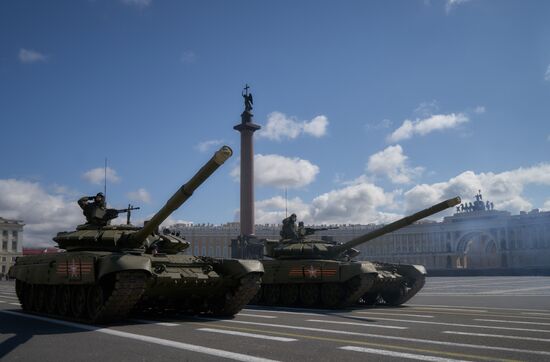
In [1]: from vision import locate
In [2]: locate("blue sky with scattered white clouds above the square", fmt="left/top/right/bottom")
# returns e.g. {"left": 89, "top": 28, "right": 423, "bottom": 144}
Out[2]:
{"left": 0, "top": 0, "right": 550, "bottom": 244}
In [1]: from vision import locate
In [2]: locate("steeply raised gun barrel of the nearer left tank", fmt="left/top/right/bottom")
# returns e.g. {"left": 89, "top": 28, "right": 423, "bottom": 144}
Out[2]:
{"left": 130, "top": 146, "right": 233, "bottom": 242}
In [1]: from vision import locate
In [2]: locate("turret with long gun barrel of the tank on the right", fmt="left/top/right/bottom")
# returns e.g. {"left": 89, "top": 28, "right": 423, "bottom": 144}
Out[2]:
{"left": 266, "top": 197, "right": 460, "bottom": 259}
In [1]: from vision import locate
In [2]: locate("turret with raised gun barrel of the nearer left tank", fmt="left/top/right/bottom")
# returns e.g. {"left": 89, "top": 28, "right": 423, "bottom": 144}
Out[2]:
{"left": 53, "top": 146, "right": 233, "bottom": 253}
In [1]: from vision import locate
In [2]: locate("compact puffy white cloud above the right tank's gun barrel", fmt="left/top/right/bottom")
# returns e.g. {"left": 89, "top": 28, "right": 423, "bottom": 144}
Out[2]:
{"left": 367, "top": 145, "right": 424, "bottom": 184}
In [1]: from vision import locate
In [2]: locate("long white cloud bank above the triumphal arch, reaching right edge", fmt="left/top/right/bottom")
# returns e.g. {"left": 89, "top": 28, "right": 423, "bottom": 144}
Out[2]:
{"left": 404, "top": 163, "right": 550, "bottom": 213}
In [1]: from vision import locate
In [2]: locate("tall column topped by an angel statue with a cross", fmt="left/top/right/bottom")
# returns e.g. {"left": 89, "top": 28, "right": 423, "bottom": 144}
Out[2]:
{"left": 233, "top": 84, "right": 261, "bottom": 240}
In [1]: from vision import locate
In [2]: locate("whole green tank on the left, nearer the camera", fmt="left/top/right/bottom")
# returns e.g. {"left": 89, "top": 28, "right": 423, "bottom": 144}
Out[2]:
{"left": 10, "top": 146, "right": 263, "bottom": 323}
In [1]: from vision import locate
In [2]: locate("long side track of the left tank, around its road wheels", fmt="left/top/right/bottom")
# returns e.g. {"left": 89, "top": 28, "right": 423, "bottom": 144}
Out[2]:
{"left": 17, "top": 271, "right": 147, "bottom": 323}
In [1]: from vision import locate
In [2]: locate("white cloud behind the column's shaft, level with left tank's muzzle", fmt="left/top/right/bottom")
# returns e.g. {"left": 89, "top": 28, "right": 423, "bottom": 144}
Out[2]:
{"left": 231, "top": 154, "right": 319, "bottom": 188}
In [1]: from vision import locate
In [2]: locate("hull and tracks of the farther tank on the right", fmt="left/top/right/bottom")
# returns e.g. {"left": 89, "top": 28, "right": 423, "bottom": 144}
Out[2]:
{"left": 252, "top": 259, "right": 426, "bottom": 309}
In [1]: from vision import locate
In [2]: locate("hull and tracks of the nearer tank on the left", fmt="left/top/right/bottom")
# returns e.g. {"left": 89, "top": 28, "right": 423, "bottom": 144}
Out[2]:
{"left": 10, "top": 251, "right": 263, "bottom": 323}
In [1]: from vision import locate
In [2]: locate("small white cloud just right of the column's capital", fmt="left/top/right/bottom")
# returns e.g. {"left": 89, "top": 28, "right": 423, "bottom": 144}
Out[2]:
{"left": 258, "top": 112, "right": 329, "bottom": 141}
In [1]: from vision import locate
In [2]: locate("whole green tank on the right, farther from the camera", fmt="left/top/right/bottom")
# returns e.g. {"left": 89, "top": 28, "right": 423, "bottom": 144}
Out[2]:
{"left": 252, "top": 197, "right": 460, "bottom": 308}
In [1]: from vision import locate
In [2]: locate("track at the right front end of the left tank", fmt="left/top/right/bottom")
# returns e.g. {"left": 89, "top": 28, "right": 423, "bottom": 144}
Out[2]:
{"left": 213, "top": 273, "right": 262, "bottom": 316}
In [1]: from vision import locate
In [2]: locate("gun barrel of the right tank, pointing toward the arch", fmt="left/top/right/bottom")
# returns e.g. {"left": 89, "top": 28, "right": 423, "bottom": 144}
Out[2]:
{"left": 331, "top": 196, "right": 461, "bottom": 255}
